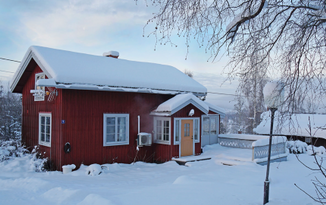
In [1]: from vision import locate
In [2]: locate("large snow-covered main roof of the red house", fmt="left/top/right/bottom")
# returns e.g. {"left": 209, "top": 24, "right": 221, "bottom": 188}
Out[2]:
{"left": 10, "top": 46, "right": 207, "bottom": 96}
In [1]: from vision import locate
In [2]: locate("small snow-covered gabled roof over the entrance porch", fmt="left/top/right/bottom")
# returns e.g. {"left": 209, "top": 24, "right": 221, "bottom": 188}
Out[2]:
{"left": 151, "top": 93, "right": 224, "bottom": 116}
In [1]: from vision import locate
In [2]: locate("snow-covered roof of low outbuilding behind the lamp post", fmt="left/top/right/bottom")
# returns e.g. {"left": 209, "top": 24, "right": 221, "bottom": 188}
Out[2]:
{"left": 254, "top": 112, "right": 326, "bottom": 139}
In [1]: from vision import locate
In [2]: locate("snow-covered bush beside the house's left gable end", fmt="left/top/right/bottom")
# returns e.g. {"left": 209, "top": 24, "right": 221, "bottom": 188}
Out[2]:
{"left": 0, "top": 140, "right": 47, "bottom": 172}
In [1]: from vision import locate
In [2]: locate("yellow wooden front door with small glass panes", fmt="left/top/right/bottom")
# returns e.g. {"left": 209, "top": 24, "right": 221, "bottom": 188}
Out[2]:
{"left": 181, "top": 120, "right": 194, "bottom": 157}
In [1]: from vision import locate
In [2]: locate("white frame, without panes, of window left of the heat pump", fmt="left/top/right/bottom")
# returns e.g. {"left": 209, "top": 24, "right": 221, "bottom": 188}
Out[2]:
{"left": 103, "top": 113, "right": 129, "bottom": 147}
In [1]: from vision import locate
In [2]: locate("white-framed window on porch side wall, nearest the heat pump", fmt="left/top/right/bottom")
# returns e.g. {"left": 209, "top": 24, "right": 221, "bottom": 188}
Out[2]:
{"left": 154, "top": 117, "right": 171, "bottom": 144}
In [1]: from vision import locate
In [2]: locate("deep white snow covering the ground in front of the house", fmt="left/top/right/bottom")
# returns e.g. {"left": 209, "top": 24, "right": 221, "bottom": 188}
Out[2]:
{"left": 0, "top": 145, "right": 325, "bottom": 205}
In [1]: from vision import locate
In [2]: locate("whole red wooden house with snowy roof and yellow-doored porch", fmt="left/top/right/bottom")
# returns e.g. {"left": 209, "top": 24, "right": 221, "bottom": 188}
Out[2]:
{"left": 10, "top": 46, "right": 223, "bottom": 170}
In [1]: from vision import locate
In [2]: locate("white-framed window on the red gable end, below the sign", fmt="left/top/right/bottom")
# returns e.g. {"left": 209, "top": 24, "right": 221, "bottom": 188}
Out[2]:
{"left": 39, "top": 113, "right": 51, "bottom": 147}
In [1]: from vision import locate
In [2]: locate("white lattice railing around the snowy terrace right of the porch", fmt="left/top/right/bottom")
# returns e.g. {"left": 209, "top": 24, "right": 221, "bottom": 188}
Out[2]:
{"left": 218, "top": 137, "right": 287, "bottom": 162}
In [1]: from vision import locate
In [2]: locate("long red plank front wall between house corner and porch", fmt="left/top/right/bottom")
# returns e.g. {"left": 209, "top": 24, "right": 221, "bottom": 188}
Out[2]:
{"left": 61, "top": 90, "right": 172, "bottom": 166}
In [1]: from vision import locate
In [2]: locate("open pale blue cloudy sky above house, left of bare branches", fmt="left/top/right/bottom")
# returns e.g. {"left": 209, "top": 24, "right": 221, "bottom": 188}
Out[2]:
{"left": 0, "top": 0, "right": 237, "bottom": 109}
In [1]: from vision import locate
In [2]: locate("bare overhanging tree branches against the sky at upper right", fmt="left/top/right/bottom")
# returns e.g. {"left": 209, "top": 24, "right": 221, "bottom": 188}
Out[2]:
{"left": 141, "top": 0, "right": 326, "bottom": 111}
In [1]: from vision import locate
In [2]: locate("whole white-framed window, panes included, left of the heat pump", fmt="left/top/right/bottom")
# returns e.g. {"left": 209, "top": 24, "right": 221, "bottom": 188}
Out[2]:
{"left": 103, "top": 114, "right": 129, "bottom": 146}
